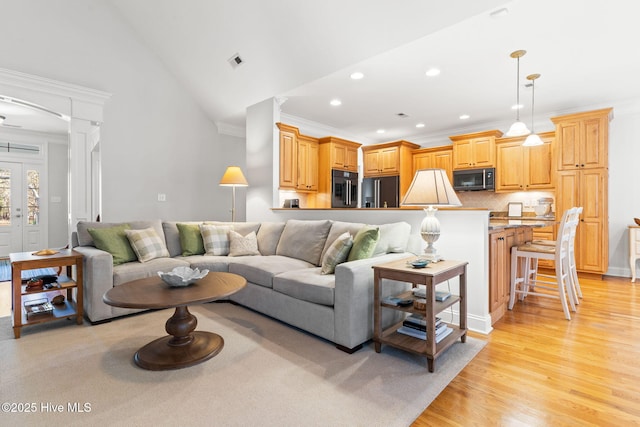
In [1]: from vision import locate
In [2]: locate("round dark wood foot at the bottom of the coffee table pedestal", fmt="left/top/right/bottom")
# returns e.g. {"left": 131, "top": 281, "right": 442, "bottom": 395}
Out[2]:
{"left": 133, "top": 331, "right": 224, "bottom": 371}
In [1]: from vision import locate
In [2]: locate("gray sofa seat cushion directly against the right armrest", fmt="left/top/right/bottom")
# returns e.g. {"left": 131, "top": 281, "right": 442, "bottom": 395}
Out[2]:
{"left": 273, "top": 267, "right": 336, "bottom": 307}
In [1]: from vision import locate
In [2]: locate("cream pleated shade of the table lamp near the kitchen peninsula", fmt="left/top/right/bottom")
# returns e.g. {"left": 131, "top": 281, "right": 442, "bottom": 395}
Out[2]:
{"left": 401, "top": 169, "right": 462, "bottom": 206}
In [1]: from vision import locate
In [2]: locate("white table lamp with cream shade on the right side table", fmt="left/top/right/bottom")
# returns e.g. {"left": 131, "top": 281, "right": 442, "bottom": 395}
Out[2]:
{"left": 400, "top": 169, "right": 462, "bottom": 262}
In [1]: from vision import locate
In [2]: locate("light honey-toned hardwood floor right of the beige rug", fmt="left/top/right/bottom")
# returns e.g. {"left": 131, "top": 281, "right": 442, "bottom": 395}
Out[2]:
{"left": 413, "top": 278, "right": 640, "bottom": 427}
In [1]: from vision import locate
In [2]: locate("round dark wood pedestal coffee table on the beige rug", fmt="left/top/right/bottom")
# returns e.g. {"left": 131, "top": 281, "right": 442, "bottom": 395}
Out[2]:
{"left": 102, "top": 272, "right": 247, "bottom": 371}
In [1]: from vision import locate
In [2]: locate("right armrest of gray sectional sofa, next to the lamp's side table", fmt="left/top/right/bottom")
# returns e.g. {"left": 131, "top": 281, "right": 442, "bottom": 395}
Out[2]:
{"left": 334, "top": 253, "right": 411, "bottom": 348}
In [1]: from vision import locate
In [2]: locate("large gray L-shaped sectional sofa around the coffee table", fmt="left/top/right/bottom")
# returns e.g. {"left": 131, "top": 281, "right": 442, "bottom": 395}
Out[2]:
{"left": 73, "top": 220, "right": 411, "bottom": 351}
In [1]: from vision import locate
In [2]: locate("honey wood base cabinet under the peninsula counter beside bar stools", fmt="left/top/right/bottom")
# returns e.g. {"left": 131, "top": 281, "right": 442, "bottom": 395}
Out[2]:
{"left": 489, "top": 226, "right": 533, "bottom": 324}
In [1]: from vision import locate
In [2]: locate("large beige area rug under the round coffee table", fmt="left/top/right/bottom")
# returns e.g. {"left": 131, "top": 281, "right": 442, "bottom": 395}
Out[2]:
{"left": 0, "top": 303, "right": 485, "bottom": 426}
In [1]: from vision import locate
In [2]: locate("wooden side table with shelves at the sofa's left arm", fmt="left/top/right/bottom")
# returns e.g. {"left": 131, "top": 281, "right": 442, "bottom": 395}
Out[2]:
{"left": 9, "top": 249, "right": 84, "bottom": 338}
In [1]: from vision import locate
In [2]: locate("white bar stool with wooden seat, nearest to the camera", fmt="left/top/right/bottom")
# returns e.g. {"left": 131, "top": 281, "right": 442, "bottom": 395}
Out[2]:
{"left": 509, "top": 208, "right": 577, "bottom": 320}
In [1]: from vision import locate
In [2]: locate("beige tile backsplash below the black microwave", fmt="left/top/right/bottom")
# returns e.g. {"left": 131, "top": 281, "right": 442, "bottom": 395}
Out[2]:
{"left": 456, "top": 191, "right": 556, "bottom": 216}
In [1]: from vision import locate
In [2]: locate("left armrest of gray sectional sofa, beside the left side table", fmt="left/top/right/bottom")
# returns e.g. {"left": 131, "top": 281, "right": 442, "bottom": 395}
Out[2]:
{"left": 73, "top": 246, "right": 113, "bottom": 322}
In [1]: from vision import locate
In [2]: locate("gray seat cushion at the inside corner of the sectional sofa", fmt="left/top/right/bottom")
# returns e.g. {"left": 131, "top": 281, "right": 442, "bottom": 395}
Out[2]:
{"left": 229, "top": 255, "right": 314, "bottom": 288}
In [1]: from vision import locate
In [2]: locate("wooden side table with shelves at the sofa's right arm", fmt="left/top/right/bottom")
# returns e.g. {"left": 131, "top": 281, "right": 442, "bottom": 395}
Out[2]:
{"left": 373, "top": 258, "right": 468, "bottom": 372}
